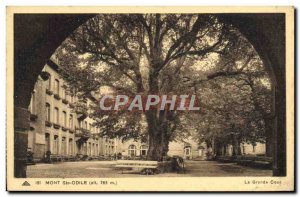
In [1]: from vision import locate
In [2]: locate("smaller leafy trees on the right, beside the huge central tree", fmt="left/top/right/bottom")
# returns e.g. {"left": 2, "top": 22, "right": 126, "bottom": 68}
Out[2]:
{"left": 185, "top": 32, "right": 273, "bottom": 156}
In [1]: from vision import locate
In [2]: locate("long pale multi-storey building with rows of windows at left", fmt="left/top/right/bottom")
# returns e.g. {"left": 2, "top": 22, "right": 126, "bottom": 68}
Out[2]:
{"left": 28, "top": 61, "right": 118, "bottom": 161}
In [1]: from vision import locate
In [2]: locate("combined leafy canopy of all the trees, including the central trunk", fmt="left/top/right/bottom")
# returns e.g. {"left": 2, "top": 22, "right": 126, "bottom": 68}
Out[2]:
{"left": 55, "top": 14, "right": 271, "bottom": 159}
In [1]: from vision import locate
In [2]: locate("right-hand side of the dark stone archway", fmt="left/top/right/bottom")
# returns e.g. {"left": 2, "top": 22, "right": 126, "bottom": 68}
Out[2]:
{"left": 220, "top": 14, "right": 286, "bottom": 176}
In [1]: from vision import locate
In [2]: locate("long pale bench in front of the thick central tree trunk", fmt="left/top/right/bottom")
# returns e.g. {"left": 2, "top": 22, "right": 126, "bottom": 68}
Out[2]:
{"left": 116, "top": 160, "right": 158, "bottom": 175}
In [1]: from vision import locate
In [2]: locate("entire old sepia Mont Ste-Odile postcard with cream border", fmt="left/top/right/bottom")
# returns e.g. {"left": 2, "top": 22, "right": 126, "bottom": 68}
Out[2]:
{"left": 6, "top": 7, "right": 295, "bottom": 192}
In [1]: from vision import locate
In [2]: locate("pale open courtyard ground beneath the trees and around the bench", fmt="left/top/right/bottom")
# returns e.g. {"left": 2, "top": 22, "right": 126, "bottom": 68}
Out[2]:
{"left": 27, "top": 161, "right": 272, "bottom": 178}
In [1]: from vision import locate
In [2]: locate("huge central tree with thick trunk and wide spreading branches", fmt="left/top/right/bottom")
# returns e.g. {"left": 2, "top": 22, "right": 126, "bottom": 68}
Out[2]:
{"left": 56, "top": 14, "right": 272, "bottom": 160}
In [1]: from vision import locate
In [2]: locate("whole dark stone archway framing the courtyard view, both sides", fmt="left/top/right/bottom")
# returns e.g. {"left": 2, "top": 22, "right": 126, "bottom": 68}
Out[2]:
{"left": 14, "top": 14, "right": 286, "bottom": 177}
